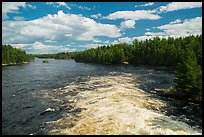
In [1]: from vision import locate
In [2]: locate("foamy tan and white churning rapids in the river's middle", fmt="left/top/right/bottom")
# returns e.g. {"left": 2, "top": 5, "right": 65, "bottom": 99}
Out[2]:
{"left": 37, "top": 75, "right": 201, "bottom": 135}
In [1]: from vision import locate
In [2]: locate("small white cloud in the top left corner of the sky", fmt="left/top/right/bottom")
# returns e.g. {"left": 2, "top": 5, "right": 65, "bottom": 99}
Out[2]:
{"left": 2, "top": 2, "right": 26, "bottom": 19}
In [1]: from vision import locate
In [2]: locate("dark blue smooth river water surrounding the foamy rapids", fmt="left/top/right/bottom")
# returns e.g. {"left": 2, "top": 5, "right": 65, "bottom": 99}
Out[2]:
{"left": 2, "top": 59, "right": 202, "bottom": 135}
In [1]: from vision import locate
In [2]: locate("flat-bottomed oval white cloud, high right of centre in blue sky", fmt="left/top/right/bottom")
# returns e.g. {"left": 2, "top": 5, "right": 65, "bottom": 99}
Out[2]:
{"left": 104, "top": 10, "right": 161, "bottom": 20}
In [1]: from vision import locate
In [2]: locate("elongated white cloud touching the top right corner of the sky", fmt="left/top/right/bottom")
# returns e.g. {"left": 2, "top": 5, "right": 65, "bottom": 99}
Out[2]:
{"left": 157, "top": 2, "right": 202, "bottom": 13}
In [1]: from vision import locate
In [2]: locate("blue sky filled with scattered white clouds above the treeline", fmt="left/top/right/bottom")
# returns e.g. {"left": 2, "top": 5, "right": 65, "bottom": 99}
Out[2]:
{"left": 2, "top": 2, "right": 202, "bottom": 54}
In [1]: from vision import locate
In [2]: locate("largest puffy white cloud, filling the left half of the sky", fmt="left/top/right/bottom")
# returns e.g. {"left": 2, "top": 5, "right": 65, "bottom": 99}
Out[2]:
{"left": 2, "top": 11, "right": 121, "bottom": 44}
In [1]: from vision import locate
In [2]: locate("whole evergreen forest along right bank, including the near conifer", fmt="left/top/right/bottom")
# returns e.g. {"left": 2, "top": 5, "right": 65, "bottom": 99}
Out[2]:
{"left": 35, "top": 35, "right": 202, "bottom": 101}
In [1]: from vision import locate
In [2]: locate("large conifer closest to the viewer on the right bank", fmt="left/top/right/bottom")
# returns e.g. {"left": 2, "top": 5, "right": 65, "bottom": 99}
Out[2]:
{"left": 174, "top": 48, "right": 202, "bottom": 99}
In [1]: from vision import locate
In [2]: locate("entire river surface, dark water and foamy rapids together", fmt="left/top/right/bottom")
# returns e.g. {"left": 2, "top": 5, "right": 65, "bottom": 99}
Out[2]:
{"left": 2, "top": 58, "right": 202, "bottom": 135}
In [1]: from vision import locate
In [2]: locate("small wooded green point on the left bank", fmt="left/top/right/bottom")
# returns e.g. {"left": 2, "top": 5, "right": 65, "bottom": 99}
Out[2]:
{"left": 2, "top": 45, "right": 35, "bottom": 65}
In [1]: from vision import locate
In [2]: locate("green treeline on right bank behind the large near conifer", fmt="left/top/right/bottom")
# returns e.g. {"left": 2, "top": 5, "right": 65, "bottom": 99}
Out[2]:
{"left": 73, "top": 35, "right": 202, "bottom": 67}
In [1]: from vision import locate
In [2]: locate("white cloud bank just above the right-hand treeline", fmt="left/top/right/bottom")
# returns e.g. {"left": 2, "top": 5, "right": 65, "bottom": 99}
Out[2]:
{"left": 118, "top": 17, "right": 202, "bottom": 43}
